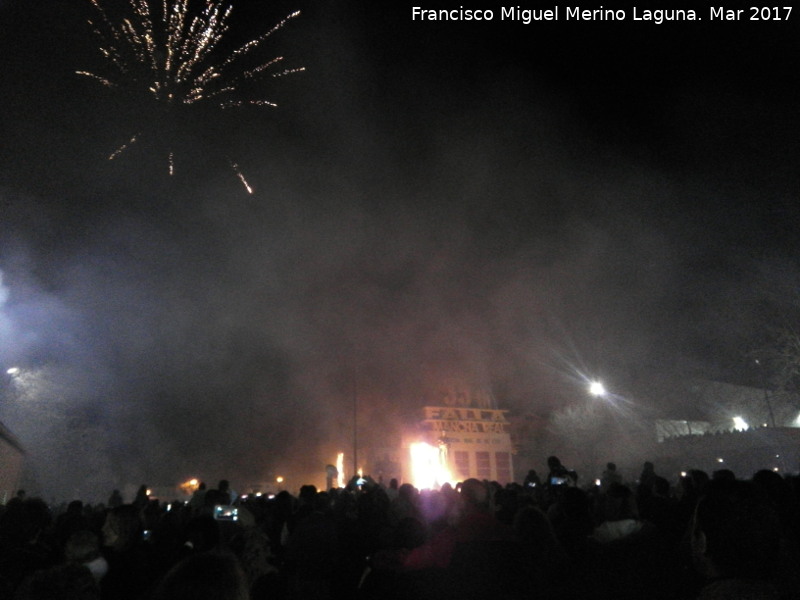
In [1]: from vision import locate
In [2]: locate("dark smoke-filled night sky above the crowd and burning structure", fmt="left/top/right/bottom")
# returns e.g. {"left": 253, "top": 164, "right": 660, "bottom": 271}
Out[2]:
{"left": 0, "top": 0, "right": 800, "bottom": 499}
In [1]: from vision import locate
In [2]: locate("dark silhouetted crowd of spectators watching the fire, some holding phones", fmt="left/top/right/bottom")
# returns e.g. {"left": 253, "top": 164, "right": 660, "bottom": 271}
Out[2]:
{"left": 0, "top": 457, "right": 800, "bottom": 600}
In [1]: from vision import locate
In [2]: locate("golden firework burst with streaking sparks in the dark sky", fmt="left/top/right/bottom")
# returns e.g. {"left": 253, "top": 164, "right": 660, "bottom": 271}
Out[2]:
{"left": 76, "top": 0, "right": 304, "bottom": 193}
